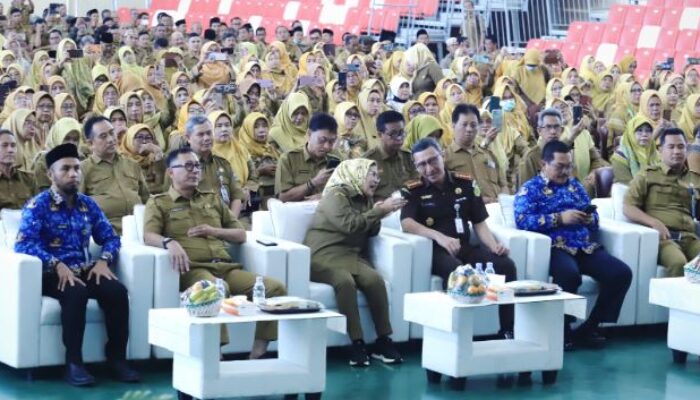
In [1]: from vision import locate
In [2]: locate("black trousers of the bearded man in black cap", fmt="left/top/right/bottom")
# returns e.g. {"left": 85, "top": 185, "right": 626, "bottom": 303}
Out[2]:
{"left": 42, "top": 272, "right": 129, "bottom": 364}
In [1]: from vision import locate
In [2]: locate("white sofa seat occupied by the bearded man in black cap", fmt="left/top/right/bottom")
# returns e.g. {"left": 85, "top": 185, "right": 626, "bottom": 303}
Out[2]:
{"left": 0, "top": 210, "right": 154, "bottom": 368}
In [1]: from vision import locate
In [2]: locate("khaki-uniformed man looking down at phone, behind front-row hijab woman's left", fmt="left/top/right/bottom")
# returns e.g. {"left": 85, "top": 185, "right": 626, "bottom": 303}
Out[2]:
{"left": 275, "top": 113, "right": 340, "bottom": 202}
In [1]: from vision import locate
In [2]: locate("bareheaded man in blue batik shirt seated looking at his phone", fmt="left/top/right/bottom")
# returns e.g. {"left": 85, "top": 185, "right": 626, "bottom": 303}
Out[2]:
{"left": 515, "top": 140, "right": 632, "bottom": 349}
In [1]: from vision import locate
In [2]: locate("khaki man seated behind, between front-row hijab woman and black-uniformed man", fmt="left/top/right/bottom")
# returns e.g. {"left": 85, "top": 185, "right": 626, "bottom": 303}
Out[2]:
{"left": 362, "top": 110, "right": 418, "bottom": 200}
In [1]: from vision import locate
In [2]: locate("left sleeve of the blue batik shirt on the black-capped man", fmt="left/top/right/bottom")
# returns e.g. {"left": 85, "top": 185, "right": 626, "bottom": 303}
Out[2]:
{"left": 15, "top": 196, "right": 54, "bottom": 270}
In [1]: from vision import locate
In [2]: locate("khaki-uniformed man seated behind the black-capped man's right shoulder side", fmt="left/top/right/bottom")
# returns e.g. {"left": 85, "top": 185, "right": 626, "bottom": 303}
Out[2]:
{"left": 80, "top": 115, "right": 149, "bottom": 234}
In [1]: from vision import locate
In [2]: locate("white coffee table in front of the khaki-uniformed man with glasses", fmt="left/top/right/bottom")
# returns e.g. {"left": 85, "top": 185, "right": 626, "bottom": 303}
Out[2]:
{"left": 148, "top": 308, "right": 346, "bottom": 399}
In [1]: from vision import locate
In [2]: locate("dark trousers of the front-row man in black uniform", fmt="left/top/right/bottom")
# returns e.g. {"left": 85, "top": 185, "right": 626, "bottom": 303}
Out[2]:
{"left": 432, "top": 242, "right": 517, "bottom": 331}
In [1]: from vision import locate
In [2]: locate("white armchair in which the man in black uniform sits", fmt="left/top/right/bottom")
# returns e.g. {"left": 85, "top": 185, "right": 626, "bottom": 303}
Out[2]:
{"left": 382, "top": 211, "right": 527, "bottom": 339}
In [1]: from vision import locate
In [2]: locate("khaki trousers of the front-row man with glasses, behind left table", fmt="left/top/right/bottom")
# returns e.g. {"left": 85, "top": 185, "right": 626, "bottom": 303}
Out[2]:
{"left": 180, "top": 262, "right": 287, "bottom": 345}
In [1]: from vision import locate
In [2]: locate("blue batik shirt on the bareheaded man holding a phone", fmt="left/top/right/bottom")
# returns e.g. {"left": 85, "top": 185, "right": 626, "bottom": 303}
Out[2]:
{"left": 514, "top": 174, "right": 600, "bottom": 254}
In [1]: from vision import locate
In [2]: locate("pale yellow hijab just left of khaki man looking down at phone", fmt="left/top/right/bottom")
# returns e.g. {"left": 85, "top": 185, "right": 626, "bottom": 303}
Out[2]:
{"left": 270, "top": 92, "right": 311, "bottom": 152}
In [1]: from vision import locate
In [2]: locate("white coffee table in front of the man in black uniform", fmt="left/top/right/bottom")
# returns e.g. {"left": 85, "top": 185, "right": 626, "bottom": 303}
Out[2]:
{"left": 404, "top": 292, "right": 586, "bottom": 389}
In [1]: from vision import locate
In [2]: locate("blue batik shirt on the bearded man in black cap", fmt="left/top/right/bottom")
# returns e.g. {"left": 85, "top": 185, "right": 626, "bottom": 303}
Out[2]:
{"left": 15, "top": 189, "right": 121, "bottom": 272}
